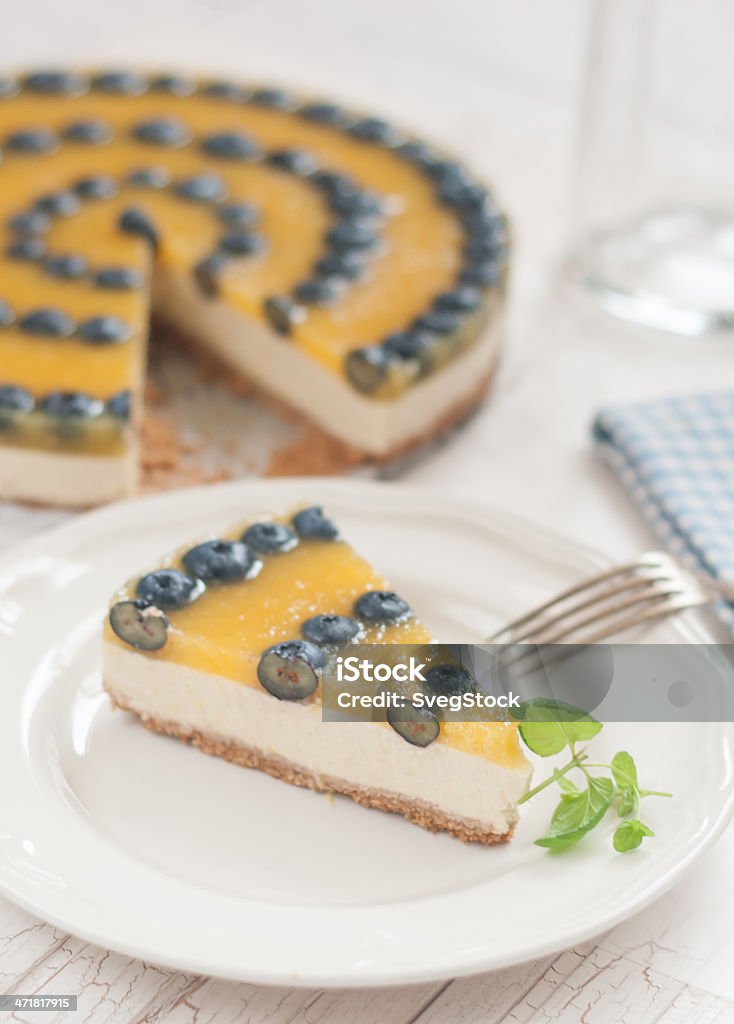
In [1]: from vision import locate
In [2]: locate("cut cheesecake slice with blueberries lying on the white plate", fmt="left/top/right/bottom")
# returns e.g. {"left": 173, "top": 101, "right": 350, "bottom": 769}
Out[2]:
{"left": 103, "top": 508, "right": 530, "bottom": 844}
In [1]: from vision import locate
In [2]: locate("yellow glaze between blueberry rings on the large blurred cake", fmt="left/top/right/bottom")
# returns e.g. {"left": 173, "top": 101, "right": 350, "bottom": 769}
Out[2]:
{"left": 0, "top": 70, "right": 481, "bottom": 446}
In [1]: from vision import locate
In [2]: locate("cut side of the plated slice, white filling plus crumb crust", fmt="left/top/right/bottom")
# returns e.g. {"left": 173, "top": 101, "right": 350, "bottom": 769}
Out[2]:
{"left": 103, "top": 644, "right": 531, "bottom": 846}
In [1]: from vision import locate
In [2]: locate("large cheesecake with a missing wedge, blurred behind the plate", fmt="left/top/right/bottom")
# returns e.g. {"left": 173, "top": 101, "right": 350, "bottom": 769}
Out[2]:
{"left": 0, "top": 71, "right": 508, "bottom": 505}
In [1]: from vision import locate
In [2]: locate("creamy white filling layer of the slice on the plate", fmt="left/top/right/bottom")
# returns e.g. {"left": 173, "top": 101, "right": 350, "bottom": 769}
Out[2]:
{"left": 104, "top": 643, "right": 531, "bottom": 838}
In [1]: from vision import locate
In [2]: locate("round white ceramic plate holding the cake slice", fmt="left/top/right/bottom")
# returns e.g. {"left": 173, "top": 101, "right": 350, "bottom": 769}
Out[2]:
{"left": 0, "top": 479, "right": 734, "bottom": 986}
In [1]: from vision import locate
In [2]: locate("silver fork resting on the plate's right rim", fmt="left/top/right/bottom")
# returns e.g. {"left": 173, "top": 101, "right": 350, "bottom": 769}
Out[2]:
{"left": 487, "top": 551, "right": 734, "bottom": 646}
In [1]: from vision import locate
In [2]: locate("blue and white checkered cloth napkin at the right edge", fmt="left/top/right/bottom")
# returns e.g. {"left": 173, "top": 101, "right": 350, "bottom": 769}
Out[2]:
{"left": 593, "top": 391, "right": 734, "bottom": 628}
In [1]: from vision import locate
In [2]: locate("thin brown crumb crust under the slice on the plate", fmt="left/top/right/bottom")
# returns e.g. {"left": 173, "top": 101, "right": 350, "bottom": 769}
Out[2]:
{"left": 107, "top": 690, "right": 515, "bottom": 846}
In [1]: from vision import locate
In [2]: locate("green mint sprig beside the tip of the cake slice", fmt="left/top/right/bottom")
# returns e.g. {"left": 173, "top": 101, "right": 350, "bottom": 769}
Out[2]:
{"left": 515, "top": 697, "right": 672, "bottom": 853}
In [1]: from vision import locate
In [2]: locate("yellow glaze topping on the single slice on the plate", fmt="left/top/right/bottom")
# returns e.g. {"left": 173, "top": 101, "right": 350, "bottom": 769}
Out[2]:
{"left": 104, "top": 517, "right": 525, "bottom": 768}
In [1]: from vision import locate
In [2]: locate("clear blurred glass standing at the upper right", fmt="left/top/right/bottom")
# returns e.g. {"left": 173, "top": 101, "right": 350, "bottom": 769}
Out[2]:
{"left": 569, "top": 0, "right": 734, "bottom": 336}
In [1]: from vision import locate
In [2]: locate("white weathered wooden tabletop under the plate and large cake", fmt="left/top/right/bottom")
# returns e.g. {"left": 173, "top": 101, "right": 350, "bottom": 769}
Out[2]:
{"left": 0, "top": 0, "right": 734, "bottom": 1024}
